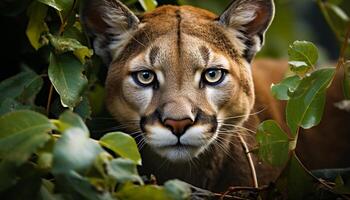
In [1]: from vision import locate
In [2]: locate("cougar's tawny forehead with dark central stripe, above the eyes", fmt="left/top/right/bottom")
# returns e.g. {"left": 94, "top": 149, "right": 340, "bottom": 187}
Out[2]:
{"left": 106, "top": 6, "right": 253, "bottom": 111}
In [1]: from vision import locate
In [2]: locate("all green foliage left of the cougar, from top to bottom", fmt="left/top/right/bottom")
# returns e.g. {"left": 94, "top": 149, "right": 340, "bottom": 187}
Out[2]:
{"left": 0, "top": 0, "right": 191, "bottom": 200}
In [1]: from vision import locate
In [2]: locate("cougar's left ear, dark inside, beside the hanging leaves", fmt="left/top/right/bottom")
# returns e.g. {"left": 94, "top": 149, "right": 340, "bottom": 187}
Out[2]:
{"left": 81, "top": 0, "right": 139, "bottom": 65}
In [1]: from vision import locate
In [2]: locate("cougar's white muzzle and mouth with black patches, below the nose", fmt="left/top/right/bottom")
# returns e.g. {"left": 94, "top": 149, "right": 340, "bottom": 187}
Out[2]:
{"left": 140, "top": 110, "right": 218, "bottom": 161}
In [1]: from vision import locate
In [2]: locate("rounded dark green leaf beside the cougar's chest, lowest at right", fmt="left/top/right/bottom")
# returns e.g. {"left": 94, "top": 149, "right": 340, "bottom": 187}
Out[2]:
{"left": 256, "top": 120, "right": 290, "bottom": 166}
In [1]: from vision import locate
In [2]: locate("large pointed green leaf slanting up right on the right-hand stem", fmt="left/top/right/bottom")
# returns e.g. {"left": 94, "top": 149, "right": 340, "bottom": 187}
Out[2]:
{"left": 286, "top": 68, "right": 335, "bottom": 136}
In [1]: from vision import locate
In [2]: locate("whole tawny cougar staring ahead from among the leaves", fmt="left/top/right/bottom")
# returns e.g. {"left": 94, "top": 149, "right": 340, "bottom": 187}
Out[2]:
{"left": 82, "top": 0, "right": 349, "bottom": 191}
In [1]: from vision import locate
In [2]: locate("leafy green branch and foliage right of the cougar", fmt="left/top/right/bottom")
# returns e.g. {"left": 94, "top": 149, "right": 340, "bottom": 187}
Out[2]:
{"left": 256, "top": 1, "right": 350, "bottom": 199}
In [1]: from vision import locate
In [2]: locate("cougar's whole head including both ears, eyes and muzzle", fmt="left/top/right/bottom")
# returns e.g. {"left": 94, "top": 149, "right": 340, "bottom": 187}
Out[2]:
{"left": 82, "top": 0, "right": 274, "bottom": 161}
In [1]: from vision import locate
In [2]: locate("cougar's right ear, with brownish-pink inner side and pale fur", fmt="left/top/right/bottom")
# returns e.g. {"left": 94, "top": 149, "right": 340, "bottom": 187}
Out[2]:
{"left": 219, "top": 0, "right": 275, "bottom": 62}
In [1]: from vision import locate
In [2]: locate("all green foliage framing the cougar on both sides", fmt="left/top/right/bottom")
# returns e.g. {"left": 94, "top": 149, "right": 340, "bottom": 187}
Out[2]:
{"left": 0, "top": 0, "right": 350, "bottom": 200}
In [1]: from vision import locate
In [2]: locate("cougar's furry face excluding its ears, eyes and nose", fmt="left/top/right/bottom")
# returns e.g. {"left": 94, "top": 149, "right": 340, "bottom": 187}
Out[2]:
{"left": 106, "top": 6, "right": 254, "bottom": 160}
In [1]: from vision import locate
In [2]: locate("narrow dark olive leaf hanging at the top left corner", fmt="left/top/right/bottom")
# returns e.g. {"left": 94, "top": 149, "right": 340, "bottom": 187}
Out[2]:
{"left": 26, "top": 1, "right": 49, "bottom": 50}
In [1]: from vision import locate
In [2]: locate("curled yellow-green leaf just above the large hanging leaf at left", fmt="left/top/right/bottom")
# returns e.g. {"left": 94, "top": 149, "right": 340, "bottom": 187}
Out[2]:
{"left": 49, "top": 35, "right": 93, "bottom": 64}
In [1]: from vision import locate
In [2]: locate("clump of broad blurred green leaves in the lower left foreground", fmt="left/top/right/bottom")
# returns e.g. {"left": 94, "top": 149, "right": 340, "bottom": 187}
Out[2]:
{"left": 0, "top": 110, "right": 190, "bottom": 199}
